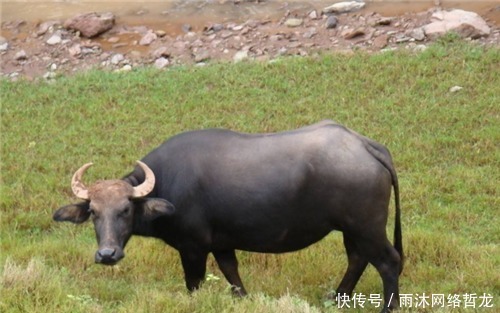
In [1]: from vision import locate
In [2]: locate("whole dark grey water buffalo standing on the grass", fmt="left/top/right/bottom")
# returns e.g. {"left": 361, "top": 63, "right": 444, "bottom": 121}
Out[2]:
{"left": 54, "top": 121, "right": 403, "bottom": 311}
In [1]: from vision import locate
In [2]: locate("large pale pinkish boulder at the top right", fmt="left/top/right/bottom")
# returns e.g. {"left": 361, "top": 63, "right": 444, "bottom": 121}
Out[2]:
{"left": 423, "top": 9, "right": 491, "bottom": 39}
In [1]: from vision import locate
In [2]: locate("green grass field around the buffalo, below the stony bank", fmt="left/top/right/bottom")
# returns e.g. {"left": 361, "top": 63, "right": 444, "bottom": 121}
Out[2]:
{"left": 0, "top": 37, "right": 500, "bottom": 313}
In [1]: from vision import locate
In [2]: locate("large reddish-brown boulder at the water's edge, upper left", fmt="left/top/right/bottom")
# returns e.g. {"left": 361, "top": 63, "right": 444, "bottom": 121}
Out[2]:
{"left": 64, "top": 12, "right": 115, "bottom": 38}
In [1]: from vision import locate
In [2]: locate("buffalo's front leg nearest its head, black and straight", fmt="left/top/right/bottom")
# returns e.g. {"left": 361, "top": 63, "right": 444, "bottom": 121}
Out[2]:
{"left": 180, "top": 251, "right": 208, "bottom": 291}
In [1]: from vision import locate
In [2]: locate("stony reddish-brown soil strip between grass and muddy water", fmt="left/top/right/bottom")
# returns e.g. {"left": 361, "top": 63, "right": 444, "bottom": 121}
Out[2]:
{"left": 0, "top": 2, "right": 500, "bottom": 80}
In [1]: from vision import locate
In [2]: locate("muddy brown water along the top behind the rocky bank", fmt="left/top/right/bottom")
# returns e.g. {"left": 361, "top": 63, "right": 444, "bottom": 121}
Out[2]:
{"left": 0, "top": 0, "right": 500, "bottom": 33}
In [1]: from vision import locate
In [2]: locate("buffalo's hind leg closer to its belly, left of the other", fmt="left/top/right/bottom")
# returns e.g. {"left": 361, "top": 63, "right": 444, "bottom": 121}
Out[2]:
{"left": 337, "top": 233, "right": 368, "bottom": 296}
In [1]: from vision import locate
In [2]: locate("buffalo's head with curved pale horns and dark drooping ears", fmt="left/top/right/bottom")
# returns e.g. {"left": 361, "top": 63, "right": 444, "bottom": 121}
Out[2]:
{"left": 53, "top": 161, "right": 174, "bottom": 265}
